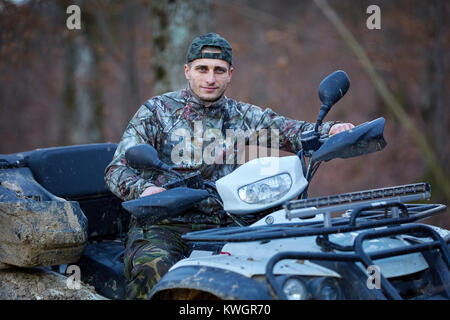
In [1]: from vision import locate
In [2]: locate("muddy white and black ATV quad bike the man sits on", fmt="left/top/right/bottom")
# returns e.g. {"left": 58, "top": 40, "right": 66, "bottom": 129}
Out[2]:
{"left": 0, "top": 71, "right": 450, "bottom": 300}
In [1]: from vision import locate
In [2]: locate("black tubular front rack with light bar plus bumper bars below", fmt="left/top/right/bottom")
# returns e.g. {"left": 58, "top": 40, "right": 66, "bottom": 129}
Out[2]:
{"left": 183, "top": 183, "right": 450, "bottom": 299}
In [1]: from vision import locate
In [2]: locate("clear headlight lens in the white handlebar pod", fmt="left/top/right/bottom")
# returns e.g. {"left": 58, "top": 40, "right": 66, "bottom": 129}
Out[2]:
{"left": 238, "top": 173, "right": 292, "bottom": 204}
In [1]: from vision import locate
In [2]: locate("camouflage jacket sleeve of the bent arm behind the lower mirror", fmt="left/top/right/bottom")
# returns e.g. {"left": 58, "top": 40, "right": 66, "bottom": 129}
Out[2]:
{"left": 104, "top": 100, "right": 162, "bottom": 200}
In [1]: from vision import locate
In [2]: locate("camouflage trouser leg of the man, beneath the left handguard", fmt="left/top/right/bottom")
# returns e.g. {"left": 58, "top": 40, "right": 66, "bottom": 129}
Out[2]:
{"left": 124, "top": 224, "right": 189, "bottom": 299}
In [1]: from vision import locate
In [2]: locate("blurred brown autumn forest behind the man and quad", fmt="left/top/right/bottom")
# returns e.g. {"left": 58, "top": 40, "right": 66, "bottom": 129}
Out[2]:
{"left": 0, "top": 0, "right": 450, "bottom": 228}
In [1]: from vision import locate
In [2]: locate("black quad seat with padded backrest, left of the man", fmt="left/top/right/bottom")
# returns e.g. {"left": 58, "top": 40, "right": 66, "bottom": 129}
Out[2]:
{"left": 28, "top": 143, "right": 129, "bottom": 299}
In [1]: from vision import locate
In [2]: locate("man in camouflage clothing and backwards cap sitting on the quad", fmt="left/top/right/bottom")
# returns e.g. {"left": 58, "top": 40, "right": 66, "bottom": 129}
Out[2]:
{"left": 105, "top": 33, "right": 353, "bottom": 299}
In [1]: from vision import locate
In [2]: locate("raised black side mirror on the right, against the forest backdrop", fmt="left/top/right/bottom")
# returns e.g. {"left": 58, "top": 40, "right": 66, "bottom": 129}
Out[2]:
{"left": 315, "top": 70, "right": 350, "bottom": 132}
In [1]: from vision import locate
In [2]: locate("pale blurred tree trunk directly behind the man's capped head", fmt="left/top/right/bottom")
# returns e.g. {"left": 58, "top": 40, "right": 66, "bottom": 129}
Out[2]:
{"left": 150, "top": 0, "right": 213, "bottom": 94}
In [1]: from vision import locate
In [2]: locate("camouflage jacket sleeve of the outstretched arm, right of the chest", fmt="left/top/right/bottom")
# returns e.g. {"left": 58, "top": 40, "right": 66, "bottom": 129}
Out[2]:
{"left": 238, "top": 103, "right": 338, "bottom": 153}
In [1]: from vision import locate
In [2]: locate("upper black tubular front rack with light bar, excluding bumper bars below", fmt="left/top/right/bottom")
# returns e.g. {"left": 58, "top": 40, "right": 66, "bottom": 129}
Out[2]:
{"left": 182, "top": 183, "right": 446, "bottom": 242}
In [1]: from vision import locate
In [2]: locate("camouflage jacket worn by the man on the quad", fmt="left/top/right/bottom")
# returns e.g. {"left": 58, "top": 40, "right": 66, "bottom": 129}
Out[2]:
{"left": 105, "top": 89, "right": 335, "bottom": 224}
